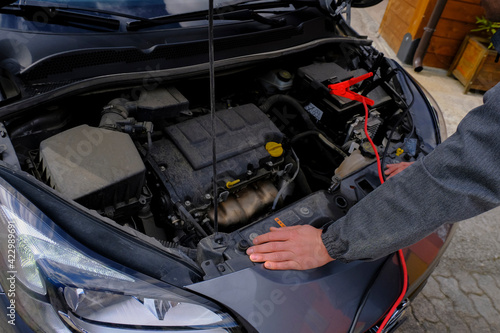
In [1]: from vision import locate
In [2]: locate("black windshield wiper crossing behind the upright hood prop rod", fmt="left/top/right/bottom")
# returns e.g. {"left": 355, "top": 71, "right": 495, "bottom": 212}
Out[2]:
{"left": 127, "top": 0, "right": 318, "bottom": 31}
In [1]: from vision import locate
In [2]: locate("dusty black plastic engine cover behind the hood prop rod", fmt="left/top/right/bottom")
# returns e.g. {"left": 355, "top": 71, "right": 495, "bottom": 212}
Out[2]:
{"left": 150, "top": 104, "right": 282, "bottom": 204}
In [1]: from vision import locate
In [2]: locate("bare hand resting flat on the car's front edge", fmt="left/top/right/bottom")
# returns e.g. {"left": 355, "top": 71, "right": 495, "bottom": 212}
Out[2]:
{"left": 247, "top": 225, "right": 334, "bottom": 270}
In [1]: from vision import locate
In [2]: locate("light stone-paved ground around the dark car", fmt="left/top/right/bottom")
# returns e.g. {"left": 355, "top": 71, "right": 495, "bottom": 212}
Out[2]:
{"left": 352, "top": 0, "right": 500, "bottom": 333}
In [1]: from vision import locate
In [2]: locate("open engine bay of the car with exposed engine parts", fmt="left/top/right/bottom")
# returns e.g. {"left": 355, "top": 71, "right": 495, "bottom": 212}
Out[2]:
{"left": 4, "top": 43, "right": 430, "bottom": 272}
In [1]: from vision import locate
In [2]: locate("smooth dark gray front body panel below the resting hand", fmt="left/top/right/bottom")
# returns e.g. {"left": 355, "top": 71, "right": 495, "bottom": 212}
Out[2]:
{"left": 187, "top": 258, "right": 401, "bottom": 332}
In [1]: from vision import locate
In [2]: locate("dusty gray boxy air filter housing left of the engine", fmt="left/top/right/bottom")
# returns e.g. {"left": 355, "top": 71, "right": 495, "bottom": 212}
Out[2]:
{"left": 39, "top": 125, "right": 146, "bottom": 210}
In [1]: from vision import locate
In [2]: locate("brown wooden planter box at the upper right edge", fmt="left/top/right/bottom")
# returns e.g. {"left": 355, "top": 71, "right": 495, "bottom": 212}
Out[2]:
{"left": 448, "top": 35, "right": 500, "bottom": 94}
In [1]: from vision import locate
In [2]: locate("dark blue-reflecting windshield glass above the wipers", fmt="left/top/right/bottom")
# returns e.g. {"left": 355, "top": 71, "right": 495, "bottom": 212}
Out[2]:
{"left": 0, "top": 0, "right": 294, "bottom": 33}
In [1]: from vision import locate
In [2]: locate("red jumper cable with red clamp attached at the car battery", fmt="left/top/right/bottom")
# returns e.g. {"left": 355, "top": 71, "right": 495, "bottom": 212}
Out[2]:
{"left": 328, "top": 72, "right": 408, "bottom": 333}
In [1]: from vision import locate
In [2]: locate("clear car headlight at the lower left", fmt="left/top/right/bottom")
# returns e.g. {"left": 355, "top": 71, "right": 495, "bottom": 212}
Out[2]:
{"left": 0, "top": 179, "right": 239, "bottom": 332}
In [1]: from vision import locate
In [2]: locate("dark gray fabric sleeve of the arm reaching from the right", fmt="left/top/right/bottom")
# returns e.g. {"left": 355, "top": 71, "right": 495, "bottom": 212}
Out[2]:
{"left": 322, "top": 84, "right": 500, "bottom": 261}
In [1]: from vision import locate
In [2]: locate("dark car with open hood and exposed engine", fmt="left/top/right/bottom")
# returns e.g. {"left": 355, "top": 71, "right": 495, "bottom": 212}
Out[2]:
{"left": 0, "top": 0, "right": 454, "bottom": 333}
